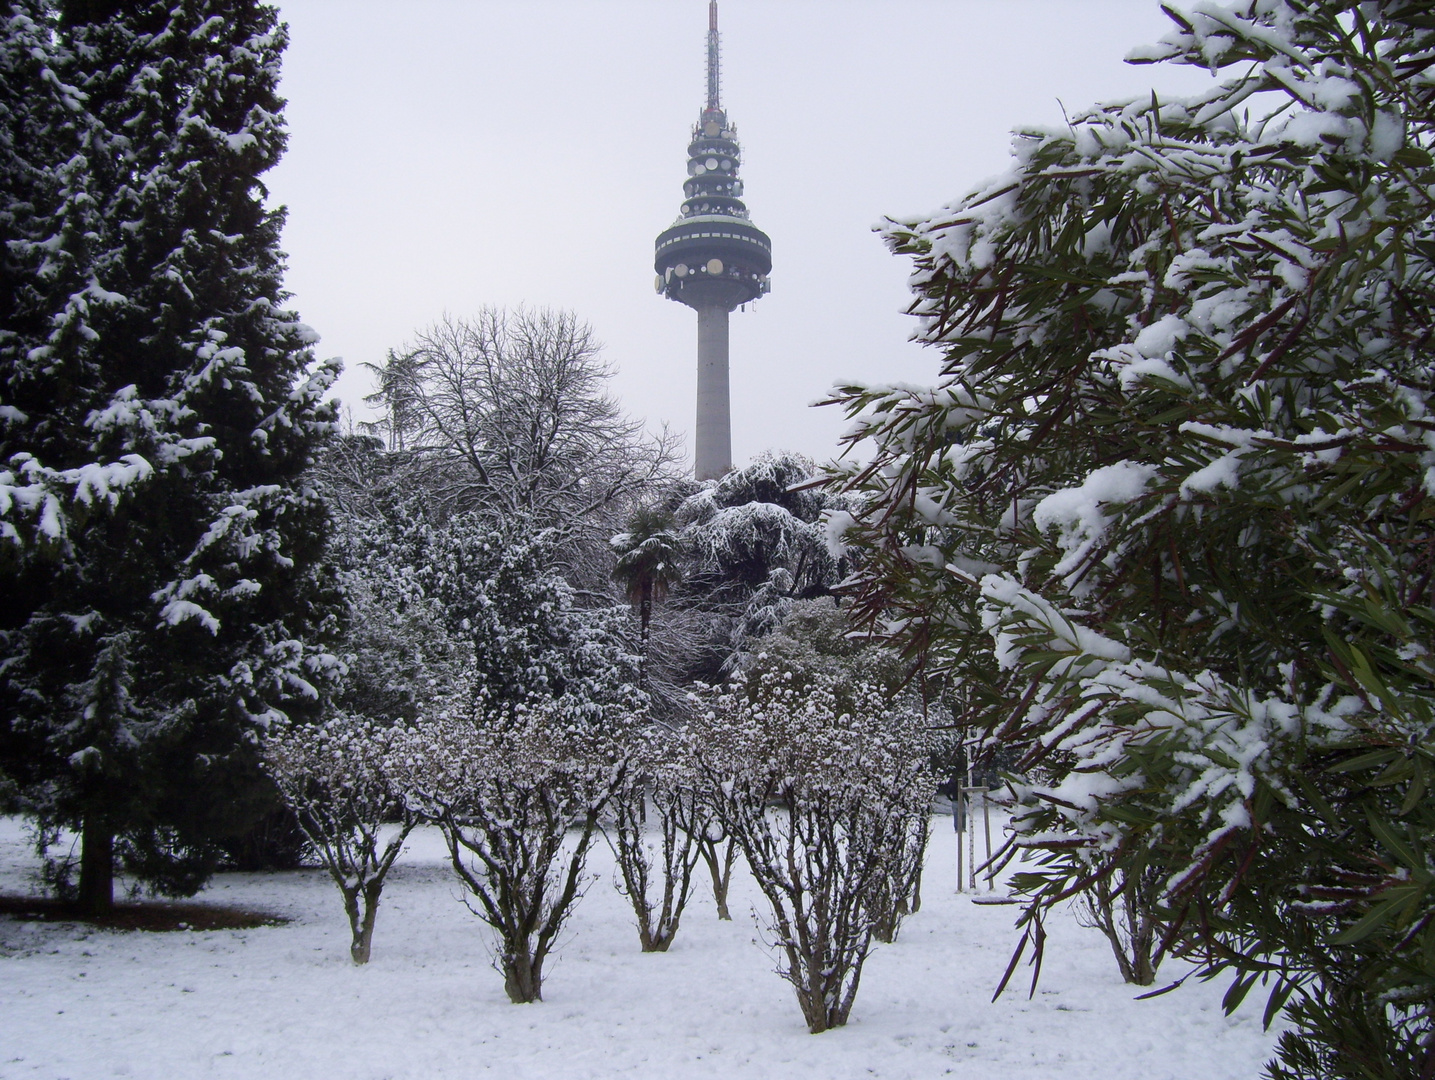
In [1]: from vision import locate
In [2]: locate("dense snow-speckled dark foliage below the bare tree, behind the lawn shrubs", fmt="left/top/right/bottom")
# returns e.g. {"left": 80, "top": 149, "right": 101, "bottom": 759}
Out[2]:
{"left": 321, "top": 437, "right": 641, "bottom": 723}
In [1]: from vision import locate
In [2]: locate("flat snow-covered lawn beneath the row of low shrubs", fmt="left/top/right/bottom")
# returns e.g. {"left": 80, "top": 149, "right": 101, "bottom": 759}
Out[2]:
{"left": 0, "top": 818, "right": 1274, "bottom": 1080}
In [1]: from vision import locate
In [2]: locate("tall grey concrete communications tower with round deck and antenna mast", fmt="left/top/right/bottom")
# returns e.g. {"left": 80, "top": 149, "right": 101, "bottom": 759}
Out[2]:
{"left": 653, "top": 0, "right": 772, "bottom": 480}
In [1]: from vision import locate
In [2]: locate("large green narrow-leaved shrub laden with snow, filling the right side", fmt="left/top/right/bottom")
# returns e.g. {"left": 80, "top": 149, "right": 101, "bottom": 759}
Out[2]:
{"left": 832, "top": 0, "right": 1435, "bottom": 1077}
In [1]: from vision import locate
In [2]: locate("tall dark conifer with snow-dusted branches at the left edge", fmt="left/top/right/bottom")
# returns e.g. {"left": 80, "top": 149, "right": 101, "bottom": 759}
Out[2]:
{"left": 0, "top": 0, "right": 334, "bottom": 908}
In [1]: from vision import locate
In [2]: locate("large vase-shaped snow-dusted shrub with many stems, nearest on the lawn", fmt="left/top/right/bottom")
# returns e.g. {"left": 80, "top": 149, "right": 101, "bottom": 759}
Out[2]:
{"left": 692, "top": 658, "right": 936, "bottom": 1034}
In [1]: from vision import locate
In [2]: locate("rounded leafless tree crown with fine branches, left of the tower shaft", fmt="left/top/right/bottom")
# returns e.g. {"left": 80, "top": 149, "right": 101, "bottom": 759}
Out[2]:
{"left": 369, "top": 307, "right": 676, "bottom": 541}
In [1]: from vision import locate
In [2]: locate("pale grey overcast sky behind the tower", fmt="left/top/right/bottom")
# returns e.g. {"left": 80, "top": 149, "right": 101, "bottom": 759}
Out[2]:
{"left": 267, "top": 0, "right": 1208, "bottom": 465}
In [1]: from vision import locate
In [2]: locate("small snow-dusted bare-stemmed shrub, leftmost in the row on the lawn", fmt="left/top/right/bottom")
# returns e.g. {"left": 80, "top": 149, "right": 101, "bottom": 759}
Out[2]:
{"left": 264, "top": 713, "right": 419, "bottom": 964}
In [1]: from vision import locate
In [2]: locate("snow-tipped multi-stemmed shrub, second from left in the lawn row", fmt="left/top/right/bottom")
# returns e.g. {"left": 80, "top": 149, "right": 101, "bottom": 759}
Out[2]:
{"left": 392, "top": 703, "right": 627, "bottom": 1003}
